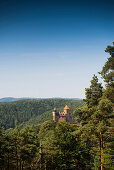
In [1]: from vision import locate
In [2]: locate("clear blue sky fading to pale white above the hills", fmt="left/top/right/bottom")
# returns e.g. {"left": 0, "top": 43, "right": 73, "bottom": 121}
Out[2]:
{"left": 0, "top": 0, "right": 114, "bottom": 98}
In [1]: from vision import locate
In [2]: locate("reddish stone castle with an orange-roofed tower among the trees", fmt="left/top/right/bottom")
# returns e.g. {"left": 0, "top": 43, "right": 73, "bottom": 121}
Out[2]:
{"left": 53, "top": 105, "right": 73, "bottom": 123}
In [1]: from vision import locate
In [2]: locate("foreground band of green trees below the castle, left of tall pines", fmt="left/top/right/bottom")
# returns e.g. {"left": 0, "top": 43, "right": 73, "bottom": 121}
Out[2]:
{"left": 0, "top": 121, "right": 92, "bottom": 170}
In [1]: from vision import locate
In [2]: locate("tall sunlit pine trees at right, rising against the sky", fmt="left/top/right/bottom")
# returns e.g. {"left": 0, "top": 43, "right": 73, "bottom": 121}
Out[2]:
{"left": 75, "top": 43, "right": 114, "bottom": 170}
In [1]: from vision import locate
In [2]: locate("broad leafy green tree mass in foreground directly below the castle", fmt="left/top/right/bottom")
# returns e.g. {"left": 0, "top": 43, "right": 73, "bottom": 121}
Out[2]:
{"left": 39, "top": 121, "right": 91, "bottom": 170}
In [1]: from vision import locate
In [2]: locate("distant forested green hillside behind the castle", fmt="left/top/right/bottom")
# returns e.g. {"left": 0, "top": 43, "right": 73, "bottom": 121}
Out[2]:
{"left": 0, "top": 99, "right": 83, "bottom": 129}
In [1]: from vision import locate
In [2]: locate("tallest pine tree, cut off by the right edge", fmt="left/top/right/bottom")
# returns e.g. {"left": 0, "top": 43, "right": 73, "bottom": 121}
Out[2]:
{"left": 99, "top": 43, "right": 114, "bottom": 169}
